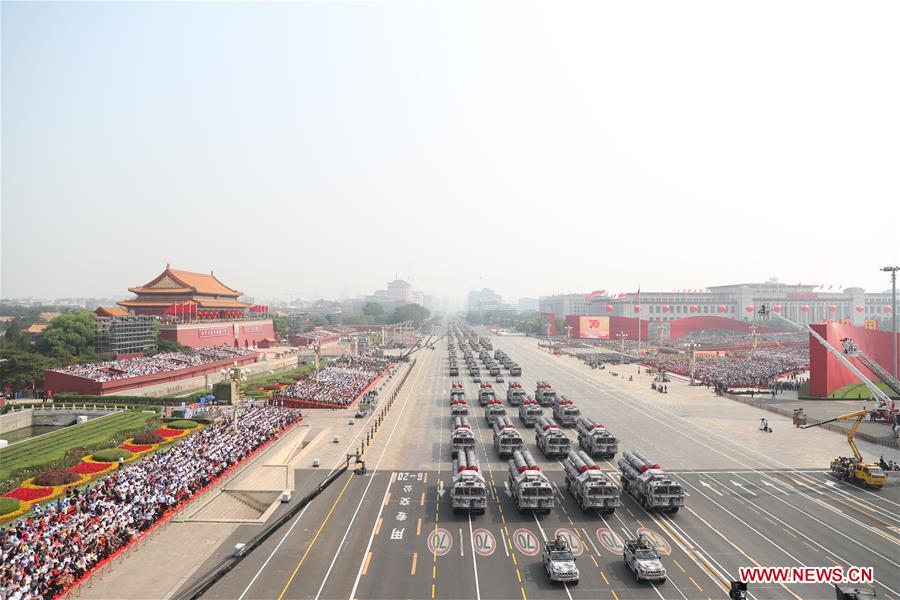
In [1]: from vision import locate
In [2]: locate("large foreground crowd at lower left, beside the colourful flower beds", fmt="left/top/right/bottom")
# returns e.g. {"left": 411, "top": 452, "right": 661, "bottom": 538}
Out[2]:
{"left": 0, "top": 407, "right": 300, "bottom": 600}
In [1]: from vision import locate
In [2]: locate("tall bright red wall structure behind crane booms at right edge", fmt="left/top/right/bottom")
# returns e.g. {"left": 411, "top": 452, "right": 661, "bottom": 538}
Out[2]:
{"left": 809, "top": 323, "right": 900, "bottom": 398}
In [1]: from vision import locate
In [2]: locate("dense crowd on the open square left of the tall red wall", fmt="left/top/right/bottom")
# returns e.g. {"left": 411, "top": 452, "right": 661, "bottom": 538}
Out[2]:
{"left": 647, "top": 346, "right": 809, "bottom": 389}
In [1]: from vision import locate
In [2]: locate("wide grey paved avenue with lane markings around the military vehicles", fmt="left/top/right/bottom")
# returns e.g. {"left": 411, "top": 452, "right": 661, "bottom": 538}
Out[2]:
{"left": 190, "top": 330, "right": 900, "bottom": 600}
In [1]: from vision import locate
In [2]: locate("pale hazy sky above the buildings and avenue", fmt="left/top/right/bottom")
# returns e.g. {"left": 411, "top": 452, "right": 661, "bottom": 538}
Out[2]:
{"left": 0, "top": 0, "right": 900, "bottom": 302}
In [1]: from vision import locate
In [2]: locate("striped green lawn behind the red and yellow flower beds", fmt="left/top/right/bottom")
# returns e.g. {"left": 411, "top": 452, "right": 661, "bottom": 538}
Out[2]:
{"left": 0, "top": 411, "right": 158, "bottom": 482}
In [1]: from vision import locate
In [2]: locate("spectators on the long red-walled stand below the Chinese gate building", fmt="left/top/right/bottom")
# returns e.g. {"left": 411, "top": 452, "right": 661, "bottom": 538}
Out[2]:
{"left": 53, "top": 346, "right": 254, "bottom": 382}
